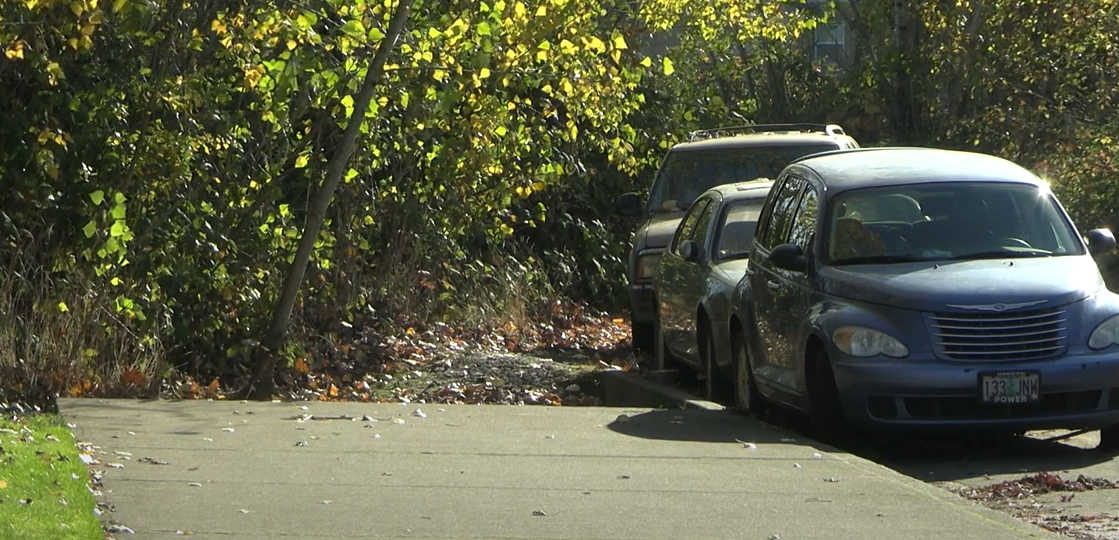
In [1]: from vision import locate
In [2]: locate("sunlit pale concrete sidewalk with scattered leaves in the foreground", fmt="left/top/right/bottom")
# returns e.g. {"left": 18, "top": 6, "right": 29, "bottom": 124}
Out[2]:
{"left": 59, "top": 399, "right": 1056, "bottom": 540}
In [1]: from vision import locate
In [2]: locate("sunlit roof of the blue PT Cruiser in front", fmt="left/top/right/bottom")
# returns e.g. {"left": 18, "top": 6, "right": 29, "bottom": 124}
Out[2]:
{"left": 790, "top": 146, "right": 1047, "bottom": 191}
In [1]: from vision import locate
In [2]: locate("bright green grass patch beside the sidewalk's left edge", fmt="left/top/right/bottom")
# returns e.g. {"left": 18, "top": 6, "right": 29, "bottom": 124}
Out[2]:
{"left": 0, "top": 415, "right": 104, "bottom": 540}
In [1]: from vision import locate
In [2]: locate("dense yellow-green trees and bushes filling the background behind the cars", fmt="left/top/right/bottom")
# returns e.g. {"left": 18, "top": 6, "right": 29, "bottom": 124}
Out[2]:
{"left": 0, "top": 0, "right": 1119, "bottom": 402}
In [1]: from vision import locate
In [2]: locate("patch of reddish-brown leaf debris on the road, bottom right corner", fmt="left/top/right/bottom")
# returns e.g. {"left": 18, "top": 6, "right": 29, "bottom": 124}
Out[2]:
{"left": 939, "top": 472, "right": 1119, "bottom": 540}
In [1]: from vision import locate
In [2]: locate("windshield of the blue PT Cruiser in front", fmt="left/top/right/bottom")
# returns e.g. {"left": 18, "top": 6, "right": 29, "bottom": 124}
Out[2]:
{"left": 826, "top": 182, "right": 1084, "bottom": 265}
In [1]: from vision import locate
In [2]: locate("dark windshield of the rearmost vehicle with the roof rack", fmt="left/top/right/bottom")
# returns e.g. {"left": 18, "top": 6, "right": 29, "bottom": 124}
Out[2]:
{"left": 648, "top": 144, "right": 838, "bottom": 211}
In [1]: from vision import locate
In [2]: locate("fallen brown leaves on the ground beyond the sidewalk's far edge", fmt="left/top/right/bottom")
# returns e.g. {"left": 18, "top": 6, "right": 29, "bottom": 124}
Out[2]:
{"left": 157, "top": 302, "right": 638, "bottom": 406}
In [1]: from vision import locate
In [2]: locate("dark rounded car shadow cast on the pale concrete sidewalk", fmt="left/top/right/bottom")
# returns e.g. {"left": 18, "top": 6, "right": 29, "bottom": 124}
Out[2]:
{"left": 606, "top": 409, "right": 812, "bottom": 445}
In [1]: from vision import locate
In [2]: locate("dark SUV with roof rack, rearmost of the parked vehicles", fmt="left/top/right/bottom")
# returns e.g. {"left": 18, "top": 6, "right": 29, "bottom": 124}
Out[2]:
{"left": 614, "top": 124, "right": 858, "bottom": 353}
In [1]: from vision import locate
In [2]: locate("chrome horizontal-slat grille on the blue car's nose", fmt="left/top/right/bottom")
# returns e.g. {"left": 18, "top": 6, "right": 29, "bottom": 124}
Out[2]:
{"left": 929, "top": 307, "right": 1069, "bottom": 361}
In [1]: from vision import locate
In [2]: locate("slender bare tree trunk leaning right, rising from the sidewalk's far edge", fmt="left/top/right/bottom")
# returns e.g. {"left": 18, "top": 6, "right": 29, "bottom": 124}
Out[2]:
{"left": 237, "top": 0, "right": 412, "bottom": 400}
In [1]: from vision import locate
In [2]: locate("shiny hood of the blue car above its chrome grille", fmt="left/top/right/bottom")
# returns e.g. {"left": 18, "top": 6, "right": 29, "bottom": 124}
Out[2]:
{"left": 819, "top": 255, "right": 1103, "bottom": 311}
